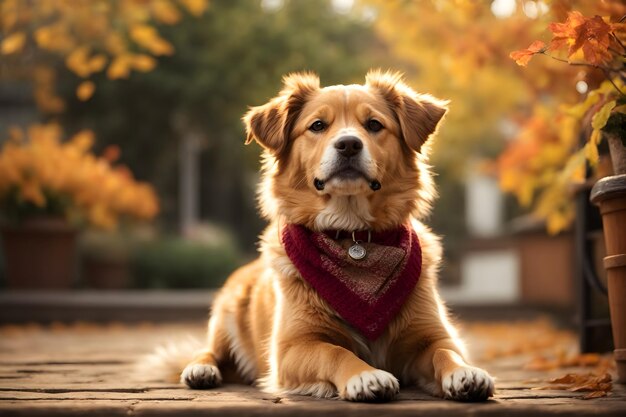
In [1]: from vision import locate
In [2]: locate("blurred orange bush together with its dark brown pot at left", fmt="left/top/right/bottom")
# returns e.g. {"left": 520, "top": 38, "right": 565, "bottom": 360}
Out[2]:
{"left": 0, "top": 124, "right": 158, "bottom": 289}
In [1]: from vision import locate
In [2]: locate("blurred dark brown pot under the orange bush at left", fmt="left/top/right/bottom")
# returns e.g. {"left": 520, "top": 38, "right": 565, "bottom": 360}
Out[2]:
{"left": 2, "top": 218, "right": 77, "bottom": 289}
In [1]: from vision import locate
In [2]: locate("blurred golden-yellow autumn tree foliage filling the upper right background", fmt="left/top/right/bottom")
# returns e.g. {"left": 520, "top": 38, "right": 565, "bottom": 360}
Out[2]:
{"left": 361, "top": 0, "right": 626, "bottom": 232}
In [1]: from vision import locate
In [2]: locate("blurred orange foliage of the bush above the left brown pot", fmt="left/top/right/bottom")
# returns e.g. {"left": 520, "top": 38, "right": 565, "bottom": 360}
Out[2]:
{"left": 0, "top": 124, "right": 158, "bottom": 228}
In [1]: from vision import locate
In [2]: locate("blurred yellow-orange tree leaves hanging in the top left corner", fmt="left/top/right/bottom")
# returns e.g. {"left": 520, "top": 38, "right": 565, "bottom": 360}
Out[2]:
{"left": 0, "top": 0, "right": 208, "bottom": 113}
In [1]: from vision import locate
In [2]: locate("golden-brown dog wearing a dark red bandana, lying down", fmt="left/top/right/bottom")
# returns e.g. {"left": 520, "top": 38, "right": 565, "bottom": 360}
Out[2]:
{"left": 180, "top": 70, "right": 494, "bottom": 401}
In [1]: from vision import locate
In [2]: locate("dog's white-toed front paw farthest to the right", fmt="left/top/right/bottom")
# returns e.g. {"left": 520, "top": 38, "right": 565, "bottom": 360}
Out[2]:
{"left": 441, "top": 366, "right": 494, "bottom": 401}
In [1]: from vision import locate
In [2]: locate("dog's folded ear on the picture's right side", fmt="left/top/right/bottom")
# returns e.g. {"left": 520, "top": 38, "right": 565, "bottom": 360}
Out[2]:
{"left": 365, "top": 71, "right": 448, "bottom": 152}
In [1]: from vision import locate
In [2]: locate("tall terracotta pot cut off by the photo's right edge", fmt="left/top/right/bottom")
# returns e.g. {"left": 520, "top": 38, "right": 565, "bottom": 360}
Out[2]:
{"left": 591, "top": 174, "right": 626, "bottom": 383}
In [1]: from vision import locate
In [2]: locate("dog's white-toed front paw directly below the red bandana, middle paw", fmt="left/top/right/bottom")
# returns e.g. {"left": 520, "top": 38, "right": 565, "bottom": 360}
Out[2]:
{"left": 342, "top": 369, "right": 400, "bottom": 401}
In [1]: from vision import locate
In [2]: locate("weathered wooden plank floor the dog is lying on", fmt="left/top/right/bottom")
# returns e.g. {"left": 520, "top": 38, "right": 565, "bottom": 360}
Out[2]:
{"left": 0, "top": 323, "right": 626, "bottom": 417}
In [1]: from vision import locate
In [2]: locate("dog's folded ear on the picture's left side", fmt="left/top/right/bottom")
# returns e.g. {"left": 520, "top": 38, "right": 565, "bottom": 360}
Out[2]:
{"left": 243, "top": 72, "right": 320, "bottom": 154}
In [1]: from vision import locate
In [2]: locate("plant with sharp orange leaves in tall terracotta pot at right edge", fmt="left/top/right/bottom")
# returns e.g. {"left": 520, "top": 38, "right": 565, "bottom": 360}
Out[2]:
{"left": 511, "top": 11, "right": 626, "bottom": 383}
